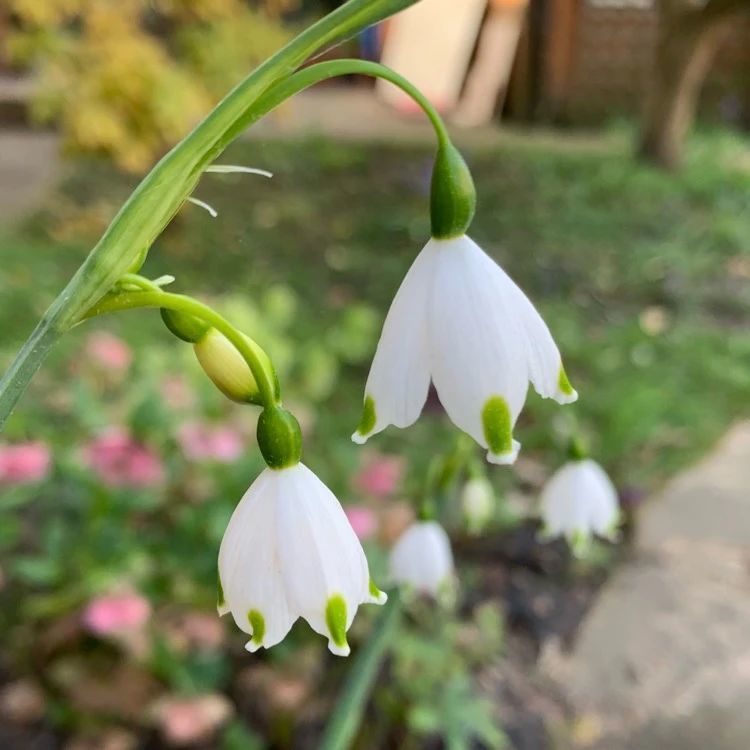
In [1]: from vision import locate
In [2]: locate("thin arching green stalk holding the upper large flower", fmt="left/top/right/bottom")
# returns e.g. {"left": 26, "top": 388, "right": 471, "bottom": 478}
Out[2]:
{"left": 253, "top": 60, "right": 450, "bottom": 145}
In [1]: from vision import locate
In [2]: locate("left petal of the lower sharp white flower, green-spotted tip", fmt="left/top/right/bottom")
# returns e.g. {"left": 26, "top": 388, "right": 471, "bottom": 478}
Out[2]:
{"left": 219, "top": 469, "right": 297, "bottom": 651}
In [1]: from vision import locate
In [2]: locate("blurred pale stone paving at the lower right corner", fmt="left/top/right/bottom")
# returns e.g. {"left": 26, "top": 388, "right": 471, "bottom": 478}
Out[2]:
{"left": 541, "top": 422, "right": 750, "bottom": 750}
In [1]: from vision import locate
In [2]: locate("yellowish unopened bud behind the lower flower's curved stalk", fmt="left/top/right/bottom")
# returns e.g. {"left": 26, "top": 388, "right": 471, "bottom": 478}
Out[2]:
{"left": 193, "top": 328, "right": 278, "bottom": 404}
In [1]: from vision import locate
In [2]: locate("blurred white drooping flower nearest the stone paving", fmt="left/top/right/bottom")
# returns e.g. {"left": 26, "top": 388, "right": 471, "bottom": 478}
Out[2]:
{"left": 540, "top": 458, "right": 620, "bottom": 553}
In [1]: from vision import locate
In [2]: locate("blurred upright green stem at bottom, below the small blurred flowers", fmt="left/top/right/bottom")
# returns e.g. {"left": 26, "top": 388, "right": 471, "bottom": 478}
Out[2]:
{"left": 318, "top": 591, "right": 401, "bottom": 750}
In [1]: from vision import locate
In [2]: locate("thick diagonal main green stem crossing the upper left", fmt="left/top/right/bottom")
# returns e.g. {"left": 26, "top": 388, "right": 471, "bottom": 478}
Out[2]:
{"left": 0, "top": 0, "right": 424, "bottom": 429}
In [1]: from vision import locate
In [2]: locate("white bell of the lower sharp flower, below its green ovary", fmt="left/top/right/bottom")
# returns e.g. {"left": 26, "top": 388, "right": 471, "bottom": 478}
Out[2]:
{"left": 219, "top": 464, "right": 386, "bottom": 656}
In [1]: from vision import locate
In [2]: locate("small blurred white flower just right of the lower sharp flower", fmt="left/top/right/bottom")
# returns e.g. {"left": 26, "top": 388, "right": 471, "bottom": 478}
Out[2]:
{"left": 388, "top": 521, "right": 454, "bottom": 597}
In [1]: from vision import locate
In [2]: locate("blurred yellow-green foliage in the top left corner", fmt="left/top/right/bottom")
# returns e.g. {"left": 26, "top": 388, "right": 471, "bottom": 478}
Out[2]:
{"left": 8, "top": 0, "right": 294, "bottom": 172}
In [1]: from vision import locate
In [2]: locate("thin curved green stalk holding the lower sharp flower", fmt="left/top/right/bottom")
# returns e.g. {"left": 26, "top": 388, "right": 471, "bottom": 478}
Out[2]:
{"left": 86, "top": 290, "right": 277, "bottom": 406}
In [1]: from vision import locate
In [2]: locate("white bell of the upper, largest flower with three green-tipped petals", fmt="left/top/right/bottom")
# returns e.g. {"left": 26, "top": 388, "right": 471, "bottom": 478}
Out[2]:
{"left": 352, "top": 235, "right": 578, "bottom": 464}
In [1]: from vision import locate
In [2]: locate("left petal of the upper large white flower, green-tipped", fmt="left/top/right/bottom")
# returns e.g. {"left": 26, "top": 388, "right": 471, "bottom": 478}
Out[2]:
{"left": 352, "top": 243, "right": 434, "bottom": 443}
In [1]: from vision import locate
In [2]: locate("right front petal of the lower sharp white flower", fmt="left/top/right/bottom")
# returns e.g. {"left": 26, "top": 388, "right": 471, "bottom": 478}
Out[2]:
{"left": 278, "top": 464, "right": 373, "bottom": 654}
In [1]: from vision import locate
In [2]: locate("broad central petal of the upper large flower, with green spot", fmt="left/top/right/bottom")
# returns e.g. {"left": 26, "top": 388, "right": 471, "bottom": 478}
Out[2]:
{"left": 428, "top": 237, "right": 528, "bottom": 463}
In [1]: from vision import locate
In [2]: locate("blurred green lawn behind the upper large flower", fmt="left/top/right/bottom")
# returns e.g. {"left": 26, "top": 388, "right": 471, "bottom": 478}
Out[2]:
{"left": 0, "top": 129, "right": 750, "bottom": 488}
